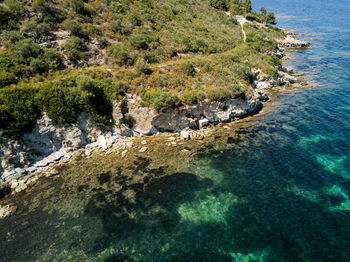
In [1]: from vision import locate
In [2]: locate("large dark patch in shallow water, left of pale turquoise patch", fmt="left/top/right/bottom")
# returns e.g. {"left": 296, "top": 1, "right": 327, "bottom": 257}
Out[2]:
{"left": 85, "top": 158, "right": 212, "bottom": 256}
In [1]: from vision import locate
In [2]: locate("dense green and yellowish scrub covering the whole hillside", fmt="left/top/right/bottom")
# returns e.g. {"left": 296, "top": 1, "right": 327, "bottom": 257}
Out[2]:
{"left": 0, "top": 0, "right": 283, "bottom": 139}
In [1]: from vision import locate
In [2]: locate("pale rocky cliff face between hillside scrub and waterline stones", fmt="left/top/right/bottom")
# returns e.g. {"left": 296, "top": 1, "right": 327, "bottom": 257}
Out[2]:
{"left": 0, "top": 38, "right": 304, "bottom": 186}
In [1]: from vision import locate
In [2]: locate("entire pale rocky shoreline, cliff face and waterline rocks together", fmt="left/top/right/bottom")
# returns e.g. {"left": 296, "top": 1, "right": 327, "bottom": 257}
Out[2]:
{"left": 0, "top": 32, "right": 310, "bottom": 205}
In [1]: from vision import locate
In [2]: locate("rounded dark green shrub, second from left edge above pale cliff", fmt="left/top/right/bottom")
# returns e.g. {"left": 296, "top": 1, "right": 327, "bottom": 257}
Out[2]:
{"left": 38, "top": 83, "right": 77, "bottom": 125}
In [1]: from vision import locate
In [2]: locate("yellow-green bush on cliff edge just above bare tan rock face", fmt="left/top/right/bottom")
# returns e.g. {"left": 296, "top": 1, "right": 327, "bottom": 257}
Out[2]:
{"left": 141, "top": 91, "right": 180, "bottom": 112}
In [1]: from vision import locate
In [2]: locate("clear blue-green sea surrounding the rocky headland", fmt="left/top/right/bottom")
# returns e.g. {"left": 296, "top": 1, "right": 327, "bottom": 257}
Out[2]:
{"left": 0, "top": 0, "right": 350, "bottom": 261}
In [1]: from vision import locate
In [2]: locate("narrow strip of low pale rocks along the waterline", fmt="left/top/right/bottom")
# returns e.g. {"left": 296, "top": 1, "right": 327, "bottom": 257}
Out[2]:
{"left": 0, "top": 29, "right": 308, "bottom": 213}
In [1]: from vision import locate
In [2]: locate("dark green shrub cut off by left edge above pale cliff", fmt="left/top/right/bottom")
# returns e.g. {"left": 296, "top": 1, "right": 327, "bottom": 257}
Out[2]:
{"left": 0, "top": 86, "right": 40, "bottom": 139}
